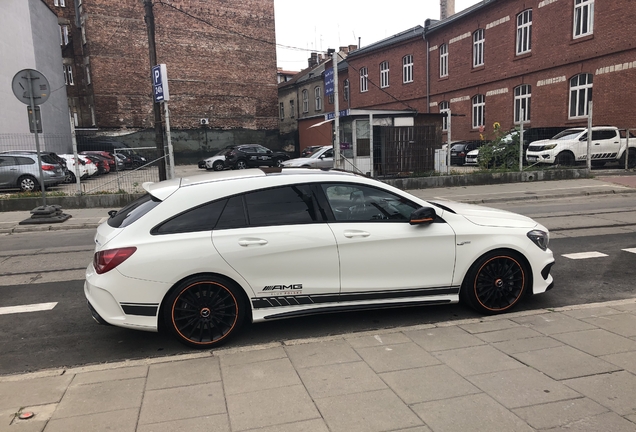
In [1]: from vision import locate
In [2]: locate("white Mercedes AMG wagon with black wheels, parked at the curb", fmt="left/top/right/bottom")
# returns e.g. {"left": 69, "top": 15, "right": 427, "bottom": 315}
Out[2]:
{"left": 84, "top": 168, "right": 554, "bottom": 348}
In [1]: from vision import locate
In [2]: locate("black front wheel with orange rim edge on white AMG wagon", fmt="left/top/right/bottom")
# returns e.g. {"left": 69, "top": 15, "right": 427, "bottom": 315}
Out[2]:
{"left": 460, "top": 251, "right": 532, "bottom": 315}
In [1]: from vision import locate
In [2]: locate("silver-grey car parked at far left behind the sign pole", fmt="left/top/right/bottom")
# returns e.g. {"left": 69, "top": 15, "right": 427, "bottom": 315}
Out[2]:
{"left": 0, "top": 152, "right": 66, "bottom": 192}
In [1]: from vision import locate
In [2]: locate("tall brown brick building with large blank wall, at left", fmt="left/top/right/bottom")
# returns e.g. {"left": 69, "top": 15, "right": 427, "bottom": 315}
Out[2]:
{"left": 46, "top": 0, "right": 278, "bottom": 158}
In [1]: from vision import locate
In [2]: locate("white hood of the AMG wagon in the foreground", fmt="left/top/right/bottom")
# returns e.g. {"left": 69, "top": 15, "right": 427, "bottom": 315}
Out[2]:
{"left": 431, "top": 201, "right": 538, "bottom": 228}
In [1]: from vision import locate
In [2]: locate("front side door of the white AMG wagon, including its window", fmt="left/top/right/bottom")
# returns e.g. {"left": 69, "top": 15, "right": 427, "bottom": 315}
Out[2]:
{"left": 322, "top": 183, "right": 457, "bottom": 301}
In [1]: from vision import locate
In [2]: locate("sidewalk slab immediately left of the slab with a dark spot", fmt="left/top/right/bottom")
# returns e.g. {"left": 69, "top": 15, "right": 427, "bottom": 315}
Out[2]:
{"left": 380, "top": 365, "right": 481, "bottom": 404}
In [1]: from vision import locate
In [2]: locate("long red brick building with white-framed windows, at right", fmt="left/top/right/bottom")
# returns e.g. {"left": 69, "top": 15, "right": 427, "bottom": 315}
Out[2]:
{"left": 286, "top": 0, "right": 636, "bottom": 147}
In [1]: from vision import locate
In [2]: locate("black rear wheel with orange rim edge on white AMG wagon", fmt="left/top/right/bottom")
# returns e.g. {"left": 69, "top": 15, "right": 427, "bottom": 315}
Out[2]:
{"left": 163, "top": 276, "right": 247, "bottom": 348}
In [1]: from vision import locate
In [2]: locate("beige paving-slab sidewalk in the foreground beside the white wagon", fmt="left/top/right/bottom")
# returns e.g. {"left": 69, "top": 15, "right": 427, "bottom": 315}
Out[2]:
{"left": 0, "top": 299, "right": 636, "bottom": 432}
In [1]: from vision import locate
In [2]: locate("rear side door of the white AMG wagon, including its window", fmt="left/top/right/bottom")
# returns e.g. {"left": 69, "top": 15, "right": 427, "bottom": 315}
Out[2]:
{"left": 212, "top": 185, "right": 340, "bottom": 305}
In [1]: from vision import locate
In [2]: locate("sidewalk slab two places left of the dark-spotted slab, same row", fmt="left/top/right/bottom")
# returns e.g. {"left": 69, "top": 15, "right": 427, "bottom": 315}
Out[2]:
{"left": 298, "top": 362, "right": 387, "bottom": 400}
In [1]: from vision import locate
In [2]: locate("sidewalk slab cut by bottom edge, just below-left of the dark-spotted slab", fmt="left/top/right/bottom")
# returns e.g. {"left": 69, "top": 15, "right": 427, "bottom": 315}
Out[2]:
{"left": 412, "top": 393, "right": 533, "bottom": 432}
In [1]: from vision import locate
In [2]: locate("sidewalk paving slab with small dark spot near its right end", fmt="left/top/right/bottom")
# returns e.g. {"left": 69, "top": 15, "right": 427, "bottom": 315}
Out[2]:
{"left": 467, "top": 367, "right": 579, "bottom": 408}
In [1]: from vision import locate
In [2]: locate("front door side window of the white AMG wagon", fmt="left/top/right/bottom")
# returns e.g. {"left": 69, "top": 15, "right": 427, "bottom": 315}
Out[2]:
{"left": 322, "top": 184, "right": 420, "bottom": 222}
